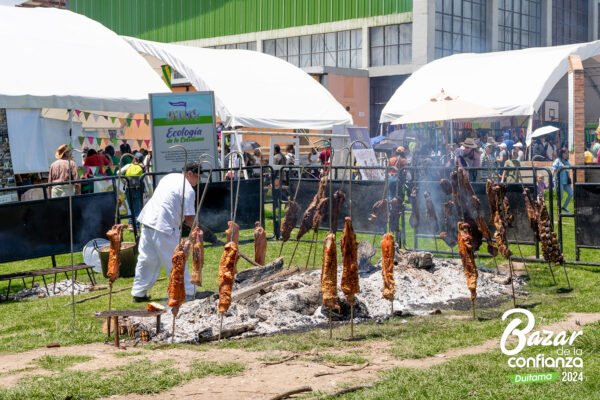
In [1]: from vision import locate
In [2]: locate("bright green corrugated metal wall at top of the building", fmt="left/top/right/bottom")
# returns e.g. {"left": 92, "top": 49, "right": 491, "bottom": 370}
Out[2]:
{"left": 69, "top": 0, "right": 412, "bottom": 42}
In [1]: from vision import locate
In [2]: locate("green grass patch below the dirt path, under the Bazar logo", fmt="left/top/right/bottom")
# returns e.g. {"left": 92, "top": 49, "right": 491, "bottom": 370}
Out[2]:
{"left": 327, "top": 323, "right": 600, "bottom": 400}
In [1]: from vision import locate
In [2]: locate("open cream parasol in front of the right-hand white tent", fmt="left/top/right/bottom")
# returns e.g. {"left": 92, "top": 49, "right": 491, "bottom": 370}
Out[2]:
{"left": 392, "top": 89, "right": 501, "bottom": 142}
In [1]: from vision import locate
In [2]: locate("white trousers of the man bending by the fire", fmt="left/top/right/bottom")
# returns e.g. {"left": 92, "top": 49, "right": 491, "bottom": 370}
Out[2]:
{"left": 131, "top": 225, "right": 196, "bottom": 297}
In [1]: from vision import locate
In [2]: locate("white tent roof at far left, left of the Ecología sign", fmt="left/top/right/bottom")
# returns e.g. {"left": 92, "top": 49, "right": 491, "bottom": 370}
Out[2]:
{"left": 0, "top": 6, "right": 170, "bottom": 113}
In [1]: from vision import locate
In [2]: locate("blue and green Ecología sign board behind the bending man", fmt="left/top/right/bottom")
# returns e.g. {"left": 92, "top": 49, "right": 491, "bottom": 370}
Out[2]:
{"left": 150, "top": 92, "right": 217, "bottom": 171}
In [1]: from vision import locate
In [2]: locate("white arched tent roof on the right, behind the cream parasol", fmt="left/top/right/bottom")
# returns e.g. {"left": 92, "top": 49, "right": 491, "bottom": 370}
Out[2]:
{"left": 380, "top": 41, "right": 600, "bottom": 122}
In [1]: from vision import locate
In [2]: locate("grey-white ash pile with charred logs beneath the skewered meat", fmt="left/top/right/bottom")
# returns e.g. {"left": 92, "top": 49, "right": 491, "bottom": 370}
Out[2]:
{"left": 131, "top": 242, "right": 523, "bottom": 343}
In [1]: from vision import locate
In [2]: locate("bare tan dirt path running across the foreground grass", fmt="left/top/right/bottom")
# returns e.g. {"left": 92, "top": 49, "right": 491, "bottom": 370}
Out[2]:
{"left": 0, "top": 313, "right": 600, "bottom": 400}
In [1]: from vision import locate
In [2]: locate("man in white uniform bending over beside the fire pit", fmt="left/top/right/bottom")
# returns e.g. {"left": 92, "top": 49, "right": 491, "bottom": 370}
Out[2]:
{"left": 131, "top": 162, "right": 202, "bottom": 302}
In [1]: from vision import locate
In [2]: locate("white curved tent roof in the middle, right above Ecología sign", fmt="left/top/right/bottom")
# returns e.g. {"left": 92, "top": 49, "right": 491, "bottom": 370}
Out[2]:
{"left": 125, "top": 37, "right": 352, "bottom": 129}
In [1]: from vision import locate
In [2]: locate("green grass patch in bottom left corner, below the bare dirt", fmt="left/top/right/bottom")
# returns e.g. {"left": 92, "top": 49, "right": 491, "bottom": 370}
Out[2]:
{"left": 0, "top": 360, "right": 244, "bottom": 400}
